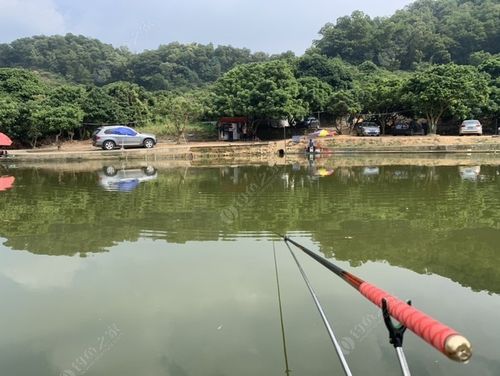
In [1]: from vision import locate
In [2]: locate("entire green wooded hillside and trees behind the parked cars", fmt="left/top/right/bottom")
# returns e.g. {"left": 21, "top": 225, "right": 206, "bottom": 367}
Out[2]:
{"left": 0, "top": 0, "right": 500, "bottom": 146}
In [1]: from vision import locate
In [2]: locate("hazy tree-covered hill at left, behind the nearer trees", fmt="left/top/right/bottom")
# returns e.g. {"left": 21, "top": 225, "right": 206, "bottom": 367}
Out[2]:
{"left": 0, "top": 34, "right": 269, "bottom": 90}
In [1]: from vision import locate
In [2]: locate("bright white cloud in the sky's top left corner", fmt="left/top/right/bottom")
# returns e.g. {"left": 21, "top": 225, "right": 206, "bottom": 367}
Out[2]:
{"left": 0, "top": 0, "right": 66, "bottom": 42}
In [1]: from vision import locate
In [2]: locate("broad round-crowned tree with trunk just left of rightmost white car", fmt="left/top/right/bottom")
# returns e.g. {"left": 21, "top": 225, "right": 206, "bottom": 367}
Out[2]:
{"left": 402, "top": 64, "right": 489, "bottom": 133}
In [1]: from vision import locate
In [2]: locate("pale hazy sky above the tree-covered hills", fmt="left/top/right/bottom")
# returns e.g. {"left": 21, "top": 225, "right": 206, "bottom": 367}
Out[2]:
{"left": 0, "top": 0, "right": 412, "bottom": 55}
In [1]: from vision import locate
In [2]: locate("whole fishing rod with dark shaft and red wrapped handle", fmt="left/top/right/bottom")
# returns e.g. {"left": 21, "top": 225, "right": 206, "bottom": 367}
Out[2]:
{"left": 276, "top": 233, "right": 472, "bottom": 367}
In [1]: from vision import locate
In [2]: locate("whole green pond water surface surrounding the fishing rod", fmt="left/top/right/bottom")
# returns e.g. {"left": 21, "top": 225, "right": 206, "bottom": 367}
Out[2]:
{"left": 0, "top": 161, "right": 500, "bottom": 376}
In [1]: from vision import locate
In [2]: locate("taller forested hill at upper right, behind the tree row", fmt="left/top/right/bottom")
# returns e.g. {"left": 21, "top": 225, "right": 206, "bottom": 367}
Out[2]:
{"left": 314, "top": 0, "right": 500, "bottom": 70}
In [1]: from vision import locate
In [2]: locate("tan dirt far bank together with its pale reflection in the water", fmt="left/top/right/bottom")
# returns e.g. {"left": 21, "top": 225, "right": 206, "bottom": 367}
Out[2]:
{"left": 0, "top": 136, "right": 500, "bottom": 172}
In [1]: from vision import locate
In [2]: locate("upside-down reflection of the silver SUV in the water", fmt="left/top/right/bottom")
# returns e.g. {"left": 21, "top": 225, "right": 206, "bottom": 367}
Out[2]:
{"left": 98, "top": 166, "right": 158, "bottom": 192}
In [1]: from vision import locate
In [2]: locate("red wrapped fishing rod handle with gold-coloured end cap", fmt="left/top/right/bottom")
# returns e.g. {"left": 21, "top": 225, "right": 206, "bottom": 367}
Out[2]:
{"left": 359, "top": 282, "right": 472, "bottom": 362}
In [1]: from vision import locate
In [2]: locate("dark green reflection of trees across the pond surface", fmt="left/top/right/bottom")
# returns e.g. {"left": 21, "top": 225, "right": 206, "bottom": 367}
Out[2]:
{"left": 0, "top": 166, "right": 500, "bottom": 292}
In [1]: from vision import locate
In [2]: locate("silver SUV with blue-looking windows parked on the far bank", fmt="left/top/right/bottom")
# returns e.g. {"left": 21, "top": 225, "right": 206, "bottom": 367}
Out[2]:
{"left": 92, "top": 125, "right": 156, "bottom": 150}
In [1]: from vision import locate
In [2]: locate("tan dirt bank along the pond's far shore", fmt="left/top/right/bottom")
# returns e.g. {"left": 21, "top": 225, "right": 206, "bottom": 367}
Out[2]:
{"left": 0, "top": 135, "right": 500, "bottom": 164}
